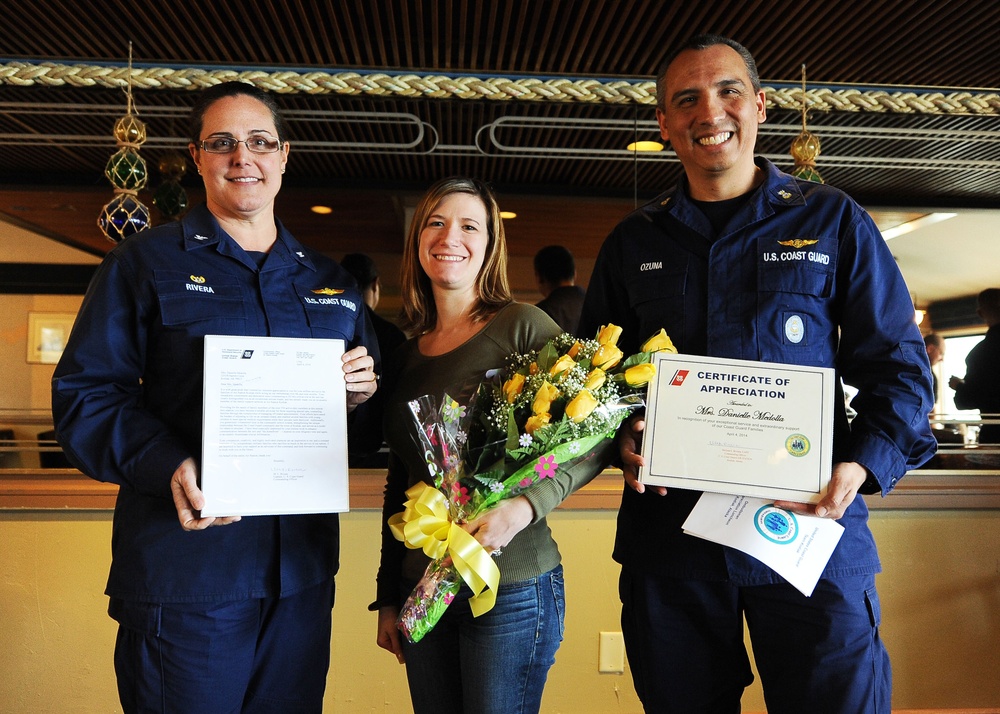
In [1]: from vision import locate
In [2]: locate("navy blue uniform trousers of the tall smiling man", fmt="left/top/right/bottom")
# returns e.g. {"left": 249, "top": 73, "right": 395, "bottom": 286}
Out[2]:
{"left": 619, "top": 567, "right": 892, "bottom": 714}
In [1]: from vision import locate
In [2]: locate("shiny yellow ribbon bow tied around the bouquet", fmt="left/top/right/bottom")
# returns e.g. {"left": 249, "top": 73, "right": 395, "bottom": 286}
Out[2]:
{"left": 389, "top": 481, "right": 500, "bottom": 617}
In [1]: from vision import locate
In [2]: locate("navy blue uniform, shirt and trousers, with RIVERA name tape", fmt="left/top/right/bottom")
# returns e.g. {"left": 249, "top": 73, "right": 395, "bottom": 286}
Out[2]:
{"left": 52, "top": 206, "right": 378, "bottom": 712}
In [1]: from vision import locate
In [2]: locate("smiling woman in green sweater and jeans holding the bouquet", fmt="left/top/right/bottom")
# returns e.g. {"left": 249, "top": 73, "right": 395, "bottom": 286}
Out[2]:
{"left": 372, "top": 178, "right": 601, "bottom": 714}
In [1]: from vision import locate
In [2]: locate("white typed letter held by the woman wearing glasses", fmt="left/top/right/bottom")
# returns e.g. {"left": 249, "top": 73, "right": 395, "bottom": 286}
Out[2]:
{"left": 201, "top": 335, "right": 348, "bottom": 517}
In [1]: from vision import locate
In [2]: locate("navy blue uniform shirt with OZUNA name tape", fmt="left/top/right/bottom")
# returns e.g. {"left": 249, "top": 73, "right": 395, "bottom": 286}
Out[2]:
{"left": 579, "top": 159, "right": 936, "bottom": 585}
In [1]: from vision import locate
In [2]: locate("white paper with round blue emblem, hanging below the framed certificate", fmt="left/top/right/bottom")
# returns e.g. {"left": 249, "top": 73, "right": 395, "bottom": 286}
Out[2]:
{"left": 683, "top": 493, "right": 844, "bottom": 597}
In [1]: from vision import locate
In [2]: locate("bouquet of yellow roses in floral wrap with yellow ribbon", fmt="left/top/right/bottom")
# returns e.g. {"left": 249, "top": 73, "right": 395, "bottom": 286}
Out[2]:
{"left": 389, "top": 325, "right": 677, "bottom": 642}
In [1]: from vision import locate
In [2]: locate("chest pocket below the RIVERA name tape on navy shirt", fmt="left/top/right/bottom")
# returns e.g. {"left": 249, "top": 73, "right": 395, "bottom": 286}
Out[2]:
{"left": 153, "top": 270, "right": 247, "bottom": 326}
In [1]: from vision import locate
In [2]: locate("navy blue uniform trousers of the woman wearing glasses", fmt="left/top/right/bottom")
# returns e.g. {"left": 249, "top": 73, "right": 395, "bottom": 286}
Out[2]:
{"left": 108, "top": 580, "right": 334, "bottom": 714}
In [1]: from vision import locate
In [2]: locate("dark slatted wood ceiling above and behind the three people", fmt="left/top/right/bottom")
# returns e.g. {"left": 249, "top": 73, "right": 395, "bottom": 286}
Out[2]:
{"left": 0, "top": 0, "right": 1000, "bottom": 278}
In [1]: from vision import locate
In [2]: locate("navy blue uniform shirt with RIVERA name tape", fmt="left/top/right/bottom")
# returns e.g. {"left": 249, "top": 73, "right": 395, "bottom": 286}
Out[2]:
{"left": 52, "top": 206, "right": 378, "bottom": 602}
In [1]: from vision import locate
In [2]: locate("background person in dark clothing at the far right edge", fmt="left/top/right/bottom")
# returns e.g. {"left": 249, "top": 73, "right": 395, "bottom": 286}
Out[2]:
{"left": 948, "top": 288, "right": 1000, "bottom": 444}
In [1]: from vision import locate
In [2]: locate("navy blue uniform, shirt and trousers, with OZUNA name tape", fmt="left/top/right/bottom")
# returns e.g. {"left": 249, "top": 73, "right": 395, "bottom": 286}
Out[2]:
{"left": 580, "top": 159, "right": 935, "bottom": 714}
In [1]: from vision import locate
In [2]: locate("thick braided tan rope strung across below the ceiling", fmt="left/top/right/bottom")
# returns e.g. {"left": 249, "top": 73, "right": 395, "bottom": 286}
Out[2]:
{"left": 0, "top": 62, "right": 1000, "bottom": 115}
